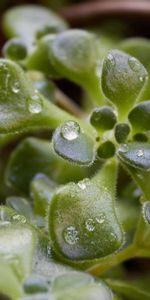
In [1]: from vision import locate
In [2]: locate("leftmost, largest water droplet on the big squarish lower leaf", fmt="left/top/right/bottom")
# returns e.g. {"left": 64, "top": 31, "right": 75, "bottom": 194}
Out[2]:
{"left": 63, "top": 225, "right": 79, "bottom": 245}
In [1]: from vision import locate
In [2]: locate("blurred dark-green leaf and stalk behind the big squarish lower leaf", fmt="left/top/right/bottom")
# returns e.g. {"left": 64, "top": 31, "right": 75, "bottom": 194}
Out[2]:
{"left": 5, "top": 137, "right": 88, "bottom": 194}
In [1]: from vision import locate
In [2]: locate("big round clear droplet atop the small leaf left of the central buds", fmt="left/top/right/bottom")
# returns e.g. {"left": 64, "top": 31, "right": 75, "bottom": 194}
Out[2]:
{"left": 61, "top": 121, "right": 80, "bottom": 141}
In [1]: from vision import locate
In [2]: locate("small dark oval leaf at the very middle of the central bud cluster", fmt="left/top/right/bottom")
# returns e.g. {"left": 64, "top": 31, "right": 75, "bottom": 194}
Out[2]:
{"left": 115, "top": 123, "right": 130, "bottom": 144}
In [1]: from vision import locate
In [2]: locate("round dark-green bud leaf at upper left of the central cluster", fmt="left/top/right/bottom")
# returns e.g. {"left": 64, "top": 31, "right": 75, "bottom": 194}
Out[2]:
{"left": 90, "top": 106, "right": 117, "bottom": 131}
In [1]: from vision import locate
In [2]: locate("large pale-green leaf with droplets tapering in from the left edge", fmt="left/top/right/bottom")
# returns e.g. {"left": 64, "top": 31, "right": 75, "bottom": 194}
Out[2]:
{"left": 0, "top": 59, "right": 70, "bottom": 133}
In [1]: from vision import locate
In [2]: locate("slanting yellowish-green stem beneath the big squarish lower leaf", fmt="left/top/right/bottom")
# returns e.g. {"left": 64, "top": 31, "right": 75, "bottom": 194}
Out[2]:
{"left": 87, "top": 244, "right": 136, "bottom": 276}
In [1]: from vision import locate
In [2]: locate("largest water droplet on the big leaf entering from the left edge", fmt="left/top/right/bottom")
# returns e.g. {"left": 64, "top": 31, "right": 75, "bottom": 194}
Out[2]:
{"left": 27, "top": 95, "right": 43, "bottom": 114}
